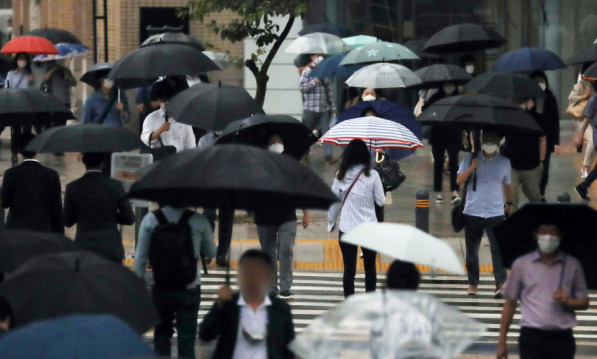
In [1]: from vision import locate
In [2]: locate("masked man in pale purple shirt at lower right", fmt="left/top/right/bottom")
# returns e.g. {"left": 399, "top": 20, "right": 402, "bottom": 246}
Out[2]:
{"left": 496, "top": 223, "right": 589, "bottom": 359}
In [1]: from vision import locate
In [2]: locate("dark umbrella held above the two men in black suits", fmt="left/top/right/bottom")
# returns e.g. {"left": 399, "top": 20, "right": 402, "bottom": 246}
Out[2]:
{"left": 27, "top": 124, "right": 146, "bottom": 153}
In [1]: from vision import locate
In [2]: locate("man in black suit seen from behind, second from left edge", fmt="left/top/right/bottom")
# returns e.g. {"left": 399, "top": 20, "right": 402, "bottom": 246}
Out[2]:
{"left": 64, "top": 153, "right": 135, "bottom": 263}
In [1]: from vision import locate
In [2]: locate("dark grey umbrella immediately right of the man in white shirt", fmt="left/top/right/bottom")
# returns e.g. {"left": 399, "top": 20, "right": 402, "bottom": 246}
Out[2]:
{"left": 166, "top": 83, "right": 264, "bottom": 131}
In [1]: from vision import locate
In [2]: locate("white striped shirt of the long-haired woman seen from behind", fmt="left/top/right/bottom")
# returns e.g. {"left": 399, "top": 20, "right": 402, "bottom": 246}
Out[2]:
{"left": 328, "top": 165, "right": 386, "bottom": 233}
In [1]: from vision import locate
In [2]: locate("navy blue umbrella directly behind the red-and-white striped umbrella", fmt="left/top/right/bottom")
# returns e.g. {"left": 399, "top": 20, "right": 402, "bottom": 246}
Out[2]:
{"left": 338, "top": 100, "right": 423, "bottom": 161}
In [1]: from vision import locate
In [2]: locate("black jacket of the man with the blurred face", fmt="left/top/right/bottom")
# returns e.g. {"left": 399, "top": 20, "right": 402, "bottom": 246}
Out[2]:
{"left": 199, "top": 293, "right": 294, "bottom": 359}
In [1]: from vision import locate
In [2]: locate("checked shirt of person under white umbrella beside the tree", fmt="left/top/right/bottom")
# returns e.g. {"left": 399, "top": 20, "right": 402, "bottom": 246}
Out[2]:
{"left": 299, "top": 67, "right": 336, "bottom": 112}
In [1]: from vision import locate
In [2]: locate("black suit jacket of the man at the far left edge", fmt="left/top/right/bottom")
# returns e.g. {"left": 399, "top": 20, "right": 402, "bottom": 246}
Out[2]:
{"left": 0, "top": 161, "right": 64, "bottom": 233}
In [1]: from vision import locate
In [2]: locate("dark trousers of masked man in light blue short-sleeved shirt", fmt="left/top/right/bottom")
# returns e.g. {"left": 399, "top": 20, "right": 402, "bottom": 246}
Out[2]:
{"left": 464, "top": 215, "right": 507, "bottom": 286}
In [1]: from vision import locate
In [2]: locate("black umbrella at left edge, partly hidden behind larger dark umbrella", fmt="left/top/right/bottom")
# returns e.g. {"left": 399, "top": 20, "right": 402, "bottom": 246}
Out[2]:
{"left": 0, "top": 229, "right": 81, "bottom": 273}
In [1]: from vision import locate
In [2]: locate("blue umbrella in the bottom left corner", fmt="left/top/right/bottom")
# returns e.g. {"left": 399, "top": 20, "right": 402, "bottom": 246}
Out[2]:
{"left": 0, "top": 314, "right": 154, "bottom": 359}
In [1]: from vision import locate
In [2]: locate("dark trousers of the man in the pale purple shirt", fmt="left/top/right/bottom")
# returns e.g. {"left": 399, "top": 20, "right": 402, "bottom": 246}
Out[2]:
{"left": 518, "top": 327, "right": 576, "bottom": 359}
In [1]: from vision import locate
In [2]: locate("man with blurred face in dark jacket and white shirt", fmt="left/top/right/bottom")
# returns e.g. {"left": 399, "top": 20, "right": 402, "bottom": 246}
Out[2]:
{"left": 199, "top": 249, "right": 294, "bottom": 359}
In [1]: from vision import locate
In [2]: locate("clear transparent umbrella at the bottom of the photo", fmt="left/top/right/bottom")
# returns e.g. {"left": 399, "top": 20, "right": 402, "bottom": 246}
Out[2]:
{"left": 290, "top": 290, "right": 485, "bottom": 359}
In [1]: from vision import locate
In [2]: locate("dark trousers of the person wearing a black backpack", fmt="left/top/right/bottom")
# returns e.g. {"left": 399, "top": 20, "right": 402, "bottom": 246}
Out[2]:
{"left": 152, "top": 287, "right": 201, "bottom": 359}
